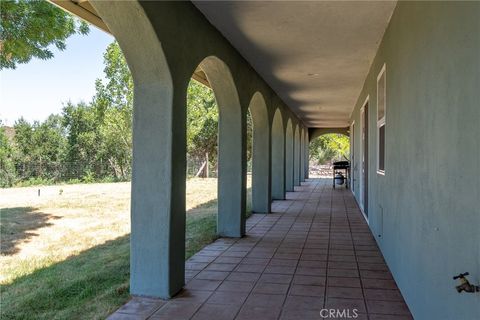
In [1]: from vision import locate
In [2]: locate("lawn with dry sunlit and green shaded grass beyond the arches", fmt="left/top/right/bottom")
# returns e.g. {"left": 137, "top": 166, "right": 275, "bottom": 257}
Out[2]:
{"left": 0, "top": 179, "right": 250, "bottom": 319}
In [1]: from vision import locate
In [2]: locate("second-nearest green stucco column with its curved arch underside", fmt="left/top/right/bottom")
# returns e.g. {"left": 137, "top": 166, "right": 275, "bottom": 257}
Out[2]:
{"left": 199, "top": 56, "right": 246, "bottom": 237}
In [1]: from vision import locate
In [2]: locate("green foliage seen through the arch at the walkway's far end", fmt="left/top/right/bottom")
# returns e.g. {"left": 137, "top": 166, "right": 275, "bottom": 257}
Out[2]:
{"left": 309, "top": 133, "right": 350, "bottom": 164}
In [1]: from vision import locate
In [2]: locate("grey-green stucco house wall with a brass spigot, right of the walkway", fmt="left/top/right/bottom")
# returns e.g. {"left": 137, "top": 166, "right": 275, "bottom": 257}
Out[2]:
{"left": 351, "top": 2, "right": 480, "bottom": 319}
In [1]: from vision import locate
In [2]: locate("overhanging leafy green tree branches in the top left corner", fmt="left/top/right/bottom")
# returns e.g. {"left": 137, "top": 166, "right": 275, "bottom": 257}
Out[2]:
{"left": 0, "top": 0, "right": 89, "bottom": 70}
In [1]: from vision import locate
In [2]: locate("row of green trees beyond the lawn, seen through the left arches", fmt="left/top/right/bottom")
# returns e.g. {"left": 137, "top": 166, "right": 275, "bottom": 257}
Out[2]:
{"left": 0, "top": 37, "right": 229, "bottom": 186}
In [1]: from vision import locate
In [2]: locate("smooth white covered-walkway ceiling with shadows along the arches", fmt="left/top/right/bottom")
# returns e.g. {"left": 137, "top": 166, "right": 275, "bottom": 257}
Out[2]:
{"left": 194, "top": 1, "right": 396, "bottom": 127}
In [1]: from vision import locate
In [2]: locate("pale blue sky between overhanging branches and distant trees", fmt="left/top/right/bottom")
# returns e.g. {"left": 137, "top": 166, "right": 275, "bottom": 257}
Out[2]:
{"left": 0, "top": 26, "right": 114, "bottom": 126}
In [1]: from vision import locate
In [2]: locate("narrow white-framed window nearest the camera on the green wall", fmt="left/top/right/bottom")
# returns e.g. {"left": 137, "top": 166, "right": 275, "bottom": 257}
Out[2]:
{"left": 377, "top": 65, "right": 387, "bottom": 174}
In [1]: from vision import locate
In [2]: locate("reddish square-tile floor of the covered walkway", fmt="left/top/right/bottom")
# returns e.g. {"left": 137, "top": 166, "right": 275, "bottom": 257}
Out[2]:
{"left": 109, "top": 179, "right": 412, "bottom": 320}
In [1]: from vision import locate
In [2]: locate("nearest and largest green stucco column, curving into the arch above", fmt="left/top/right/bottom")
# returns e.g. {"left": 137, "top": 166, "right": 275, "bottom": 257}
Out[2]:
{"left": 90, "top": 1, "right": 186, "bottom": 298}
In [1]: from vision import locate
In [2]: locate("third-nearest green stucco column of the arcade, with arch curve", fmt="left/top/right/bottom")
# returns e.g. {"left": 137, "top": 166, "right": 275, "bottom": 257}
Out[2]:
{"left": 249, "top": 92, "right": 271, "bottom": 213}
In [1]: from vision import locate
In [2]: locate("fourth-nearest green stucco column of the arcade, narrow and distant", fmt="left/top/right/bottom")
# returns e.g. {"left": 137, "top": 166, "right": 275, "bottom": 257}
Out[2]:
{"left": 272, "top": 108, "right": 286, "bottom": 200}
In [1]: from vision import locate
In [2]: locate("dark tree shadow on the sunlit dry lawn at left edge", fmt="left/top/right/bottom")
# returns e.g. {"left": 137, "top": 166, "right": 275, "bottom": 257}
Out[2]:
{"left": 0, "top": 207, "right": 60, "bottom": 255}
